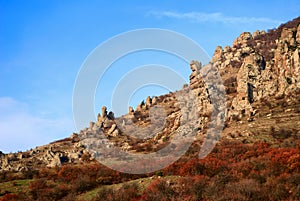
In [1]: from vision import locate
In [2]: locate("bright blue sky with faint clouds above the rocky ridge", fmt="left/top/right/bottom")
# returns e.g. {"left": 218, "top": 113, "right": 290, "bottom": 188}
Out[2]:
{"left": 0, "top": 0, "right": 300, "bottom": 152}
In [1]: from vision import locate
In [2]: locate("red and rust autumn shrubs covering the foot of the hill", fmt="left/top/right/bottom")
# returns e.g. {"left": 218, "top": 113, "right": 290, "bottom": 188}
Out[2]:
{"left": 0, "top": 140, "right": 300, "bottom": 201}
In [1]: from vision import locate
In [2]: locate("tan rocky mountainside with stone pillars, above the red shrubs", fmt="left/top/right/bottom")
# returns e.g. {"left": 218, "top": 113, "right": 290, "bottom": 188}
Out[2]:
{"left": 0, "top": 17, "right": 300, "bottom": 172}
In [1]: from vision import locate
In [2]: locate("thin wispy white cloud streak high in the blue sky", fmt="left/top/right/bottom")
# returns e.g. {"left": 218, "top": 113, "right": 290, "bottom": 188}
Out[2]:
{"left": 148, "top": 11, "right": 282, "bottom": 25}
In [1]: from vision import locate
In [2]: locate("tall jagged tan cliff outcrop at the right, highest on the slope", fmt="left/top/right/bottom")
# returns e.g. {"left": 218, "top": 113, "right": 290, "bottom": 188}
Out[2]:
{"left": 212, "top": 19, "right": 300, "bottom": 119}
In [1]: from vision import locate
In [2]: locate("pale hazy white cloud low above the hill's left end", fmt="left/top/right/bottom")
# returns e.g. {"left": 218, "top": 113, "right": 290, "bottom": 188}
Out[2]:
{"left": 0, "top": 97, "right": 74, "bottom": 152}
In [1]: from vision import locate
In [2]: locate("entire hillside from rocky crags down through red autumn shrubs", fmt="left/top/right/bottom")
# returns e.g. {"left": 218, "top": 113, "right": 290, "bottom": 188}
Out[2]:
{"left": 0, "top": 17, "right": 300, "bottom": 200}
